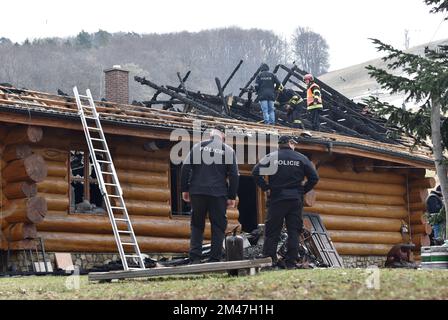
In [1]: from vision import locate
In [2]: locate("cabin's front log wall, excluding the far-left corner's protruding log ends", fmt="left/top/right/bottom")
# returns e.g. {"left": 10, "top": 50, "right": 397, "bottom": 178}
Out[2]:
{"left": 0, "top": 124, "right": 427, "bottom": 264}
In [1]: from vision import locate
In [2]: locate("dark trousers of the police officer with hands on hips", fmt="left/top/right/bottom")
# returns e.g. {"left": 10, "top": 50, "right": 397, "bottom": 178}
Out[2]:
{"left": 263, "top": 200, "right": 303, "bottom": 265}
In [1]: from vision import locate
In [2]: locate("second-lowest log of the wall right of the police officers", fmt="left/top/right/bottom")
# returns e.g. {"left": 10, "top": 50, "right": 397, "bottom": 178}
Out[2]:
{"left": 329, "top": 230, "right": 403, "bottom": 244}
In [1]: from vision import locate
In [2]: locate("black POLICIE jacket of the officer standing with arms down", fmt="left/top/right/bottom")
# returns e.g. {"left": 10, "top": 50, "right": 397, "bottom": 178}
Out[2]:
{"left": 181, "top": 137, "right": 239, "bottom": 200}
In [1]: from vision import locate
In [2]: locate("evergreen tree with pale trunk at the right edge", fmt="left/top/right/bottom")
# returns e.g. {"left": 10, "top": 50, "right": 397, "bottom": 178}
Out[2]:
{"left": 366, "top": 0, "right": 448, "bottom": 239}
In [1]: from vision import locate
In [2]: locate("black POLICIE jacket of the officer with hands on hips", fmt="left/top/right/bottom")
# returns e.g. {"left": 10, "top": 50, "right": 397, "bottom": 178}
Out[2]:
{"left": 252, "top": 148, "right": 319, "bottom": 201}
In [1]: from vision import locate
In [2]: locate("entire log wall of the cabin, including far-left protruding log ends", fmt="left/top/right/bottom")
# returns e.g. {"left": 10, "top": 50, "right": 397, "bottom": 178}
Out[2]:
{"left": 0, "top": 128, "right": 433, "bottom": 255}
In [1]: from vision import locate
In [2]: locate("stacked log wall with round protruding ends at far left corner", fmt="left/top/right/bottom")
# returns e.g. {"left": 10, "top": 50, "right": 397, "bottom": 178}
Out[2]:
{"left": 0, "top": 125, "right": 48, "bottom": 250}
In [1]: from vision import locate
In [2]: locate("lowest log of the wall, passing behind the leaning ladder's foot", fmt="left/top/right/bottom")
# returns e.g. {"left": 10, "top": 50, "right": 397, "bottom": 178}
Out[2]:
{"left": 38, "top": 231, "right": 190, "bottom": 253}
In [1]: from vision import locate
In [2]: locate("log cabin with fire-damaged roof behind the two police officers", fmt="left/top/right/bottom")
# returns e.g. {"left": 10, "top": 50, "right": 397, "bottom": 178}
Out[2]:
{"left": 0, "top": 73, "right": 435, "bottom": 270}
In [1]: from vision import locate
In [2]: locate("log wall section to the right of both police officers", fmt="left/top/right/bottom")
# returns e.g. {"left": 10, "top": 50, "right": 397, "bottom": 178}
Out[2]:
{"left": 305, "top": 164, "right": 420, "bottom": 256}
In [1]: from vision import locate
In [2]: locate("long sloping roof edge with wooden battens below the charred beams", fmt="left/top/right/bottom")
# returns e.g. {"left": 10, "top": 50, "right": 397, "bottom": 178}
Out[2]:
{"left": 0, "top": 86, "right": 434, "bottom": 168}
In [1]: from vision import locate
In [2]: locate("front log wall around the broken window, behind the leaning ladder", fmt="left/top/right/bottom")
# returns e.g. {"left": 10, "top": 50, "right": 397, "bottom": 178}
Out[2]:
{"left": 26, "top": 133, "right": 238, "bottom": 252}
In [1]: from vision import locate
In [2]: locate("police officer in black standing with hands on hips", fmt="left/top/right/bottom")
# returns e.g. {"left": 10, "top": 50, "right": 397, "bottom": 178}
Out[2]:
{"left": 252, "top": 136, "right": 319, "bottom": 269}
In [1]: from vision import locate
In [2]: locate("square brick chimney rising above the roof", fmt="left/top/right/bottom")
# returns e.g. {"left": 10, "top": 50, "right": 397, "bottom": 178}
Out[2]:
{"left": 104, "top": 65, "right": 129, "bottom": 104}
